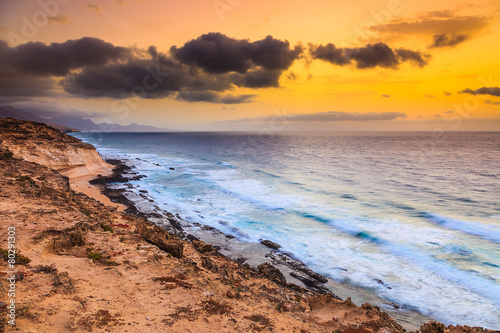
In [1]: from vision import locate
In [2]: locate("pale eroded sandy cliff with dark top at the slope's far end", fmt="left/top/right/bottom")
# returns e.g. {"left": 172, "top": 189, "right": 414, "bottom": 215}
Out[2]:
{"left": 0, "top": 119, "right": 112, "bottom": 178}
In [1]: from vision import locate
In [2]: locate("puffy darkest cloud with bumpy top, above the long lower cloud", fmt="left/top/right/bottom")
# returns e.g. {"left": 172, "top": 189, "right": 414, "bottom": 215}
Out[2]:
{"left": 170, "top": 33, "right": 302, "bottom": 73}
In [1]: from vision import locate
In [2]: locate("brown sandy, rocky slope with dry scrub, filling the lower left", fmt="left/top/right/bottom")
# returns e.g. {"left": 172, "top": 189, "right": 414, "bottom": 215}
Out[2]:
{"left": 0, "top": 119, "right": 493, "bottom": 333}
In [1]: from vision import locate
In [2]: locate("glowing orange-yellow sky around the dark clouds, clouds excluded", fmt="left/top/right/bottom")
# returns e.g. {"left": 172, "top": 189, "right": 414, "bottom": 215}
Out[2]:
{"left": 0, "top": 0, "right": 500, "bottom": 130}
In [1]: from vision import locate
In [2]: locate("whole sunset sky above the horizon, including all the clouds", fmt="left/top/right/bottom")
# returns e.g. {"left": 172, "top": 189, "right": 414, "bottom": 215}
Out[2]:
{"left": 0, "top": 0, "right": 500, "bottom": 132}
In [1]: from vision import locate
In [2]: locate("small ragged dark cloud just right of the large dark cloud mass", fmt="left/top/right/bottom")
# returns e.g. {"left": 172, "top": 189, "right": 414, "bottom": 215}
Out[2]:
{"left": 309, "top": 43, "right": 430, "bottom": 69}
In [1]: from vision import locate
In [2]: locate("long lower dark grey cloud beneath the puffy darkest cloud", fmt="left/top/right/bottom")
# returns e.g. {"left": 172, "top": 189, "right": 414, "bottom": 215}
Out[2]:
{"left": 61, "top": 48, "right": 281, "bottom": 98}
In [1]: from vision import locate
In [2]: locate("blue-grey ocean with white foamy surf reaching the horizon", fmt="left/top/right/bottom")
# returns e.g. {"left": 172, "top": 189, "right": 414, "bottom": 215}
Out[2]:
{"left": 73, "top": 132, "right": 500, "bottom": 329}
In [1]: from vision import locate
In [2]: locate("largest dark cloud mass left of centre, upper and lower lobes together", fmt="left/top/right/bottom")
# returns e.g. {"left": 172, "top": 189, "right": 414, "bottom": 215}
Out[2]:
{"left": 61, "top": 33, "right": 302, "bottom": 99}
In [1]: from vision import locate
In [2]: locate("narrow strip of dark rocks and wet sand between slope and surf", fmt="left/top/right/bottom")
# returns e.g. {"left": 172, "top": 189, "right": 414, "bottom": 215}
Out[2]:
{"left": 87, "top": 152, "right": 432, "bottom": 331}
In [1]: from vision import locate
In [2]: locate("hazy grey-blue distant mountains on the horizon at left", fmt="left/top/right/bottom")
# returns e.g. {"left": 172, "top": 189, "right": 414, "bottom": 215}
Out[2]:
{"left": 0, "top": 106, "right": 170, "bottom": 132}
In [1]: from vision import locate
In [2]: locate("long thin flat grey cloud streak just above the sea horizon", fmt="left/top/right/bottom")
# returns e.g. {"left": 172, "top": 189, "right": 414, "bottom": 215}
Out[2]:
{"left": 250, "top": 111, "right": 406, "bottom": 122}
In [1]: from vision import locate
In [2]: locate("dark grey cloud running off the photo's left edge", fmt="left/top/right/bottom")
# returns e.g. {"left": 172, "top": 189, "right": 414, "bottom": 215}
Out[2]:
{"left": 0, "top": 37, "right": 129, "bottom": 76}
